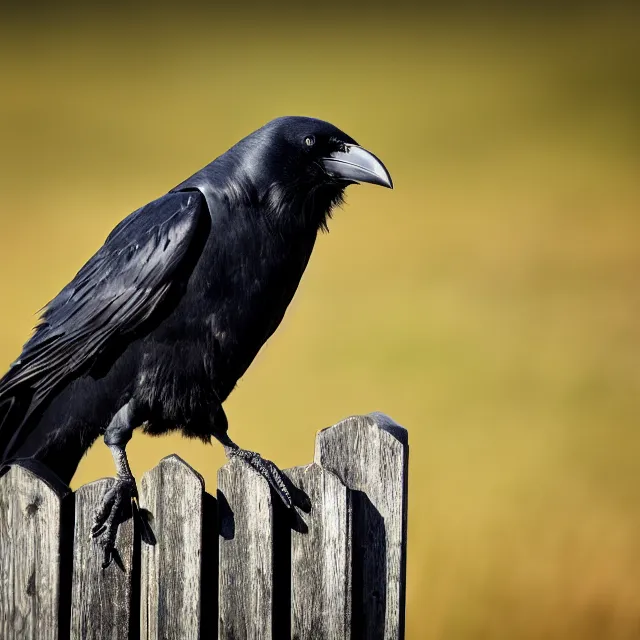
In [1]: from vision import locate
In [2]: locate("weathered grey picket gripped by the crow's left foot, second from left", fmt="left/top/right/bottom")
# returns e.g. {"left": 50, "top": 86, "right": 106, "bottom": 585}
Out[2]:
{"left": 71, "top": 478, "right": 139, "bottom": 640}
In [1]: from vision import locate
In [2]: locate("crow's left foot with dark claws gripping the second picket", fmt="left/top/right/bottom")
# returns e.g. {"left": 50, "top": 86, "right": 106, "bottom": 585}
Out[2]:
{"left": 91, "top": 476, "right": 138, "bottom": 569}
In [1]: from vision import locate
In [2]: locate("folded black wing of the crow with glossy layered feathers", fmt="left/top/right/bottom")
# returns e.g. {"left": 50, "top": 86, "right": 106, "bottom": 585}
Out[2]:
{"left": 0, "top": 191, "right": 209, "bottom": 459}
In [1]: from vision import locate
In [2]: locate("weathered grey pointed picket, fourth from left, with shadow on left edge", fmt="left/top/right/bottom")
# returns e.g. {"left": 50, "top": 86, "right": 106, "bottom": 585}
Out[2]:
{"left": 218, "top": 458, "right": 274, "bottom": 640}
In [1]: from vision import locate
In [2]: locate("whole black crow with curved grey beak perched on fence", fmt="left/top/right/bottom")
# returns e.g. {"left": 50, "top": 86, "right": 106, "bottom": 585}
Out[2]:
{"left": 0, "top": 117, "right": 392, "bottom": 564}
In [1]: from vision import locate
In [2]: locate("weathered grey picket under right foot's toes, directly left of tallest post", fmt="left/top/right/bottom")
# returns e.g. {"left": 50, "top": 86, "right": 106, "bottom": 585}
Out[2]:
{"left": 286, "top": 463, "right": 351, "bottom": 640}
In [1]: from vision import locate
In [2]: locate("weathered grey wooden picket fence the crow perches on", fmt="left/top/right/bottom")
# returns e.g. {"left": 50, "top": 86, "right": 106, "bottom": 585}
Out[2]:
{"left": 0, "top": 414, "right": 408, "bottom": 640}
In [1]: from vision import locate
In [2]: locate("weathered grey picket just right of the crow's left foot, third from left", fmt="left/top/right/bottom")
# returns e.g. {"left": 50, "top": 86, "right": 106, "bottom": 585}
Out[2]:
{"left": 140, "top": 455, "right": 204, "bottom": 640}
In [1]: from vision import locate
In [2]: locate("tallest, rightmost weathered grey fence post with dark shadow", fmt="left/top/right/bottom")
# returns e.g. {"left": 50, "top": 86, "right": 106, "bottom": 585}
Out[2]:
{"left": 315, "top": 413, "right": 409, "bottom": 640}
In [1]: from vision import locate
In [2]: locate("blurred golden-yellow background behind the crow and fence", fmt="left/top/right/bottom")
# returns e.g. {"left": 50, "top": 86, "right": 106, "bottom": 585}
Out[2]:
{"left": 0, "top": 4, "right": 640, "bottom": 640}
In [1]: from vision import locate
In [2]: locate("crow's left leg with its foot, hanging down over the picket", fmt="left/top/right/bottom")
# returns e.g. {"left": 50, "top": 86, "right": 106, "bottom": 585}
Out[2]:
{"left": 91, "top": 401, "right": 138, "bottom": 568}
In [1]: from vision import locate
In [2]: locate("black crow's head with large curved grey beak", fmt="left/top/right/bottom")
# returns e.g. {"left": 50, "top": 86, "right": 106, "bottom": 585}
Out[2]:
{"left": 232, "top": 116, "right": 393, "bottom": 228}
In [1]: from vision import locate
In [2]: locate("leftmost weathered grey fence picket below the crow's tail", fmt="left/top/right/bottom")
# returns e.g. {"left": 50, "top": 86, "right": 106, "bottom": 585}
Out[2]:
{"left": 0, "top": 465, "right": 68, "bottom": 640}
